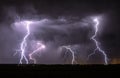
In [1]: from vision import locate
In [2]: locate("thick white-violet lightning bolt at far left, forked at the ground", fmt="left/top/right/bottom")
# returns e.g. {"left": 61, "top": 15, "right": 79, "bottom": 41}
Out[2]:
{"left": 19, "top": 21, "right": 31, "bottom": 64}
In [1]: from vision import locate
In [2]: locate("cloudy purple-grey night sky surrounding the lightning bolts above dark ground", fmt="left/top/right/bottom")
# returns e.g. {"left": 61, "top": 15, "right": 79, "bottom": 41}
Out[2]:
{"left": 0, "top": 0, "right": 120, "bottom": 64}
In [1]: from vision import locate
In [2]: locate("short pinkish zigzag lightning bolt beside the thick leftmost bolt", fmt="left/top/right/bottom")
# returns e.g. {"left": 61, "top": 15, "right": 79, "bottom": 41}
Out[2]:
{"left": 29, "top": 42, "right": 46, "bottom": 64}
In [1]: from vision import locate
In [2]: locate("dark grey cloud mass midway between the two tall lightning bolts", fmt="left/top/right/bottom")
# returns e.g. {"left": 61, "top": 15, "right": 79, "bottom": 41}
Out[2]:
{"left": 36, "top": 18, "right": 88, "bottom": 44}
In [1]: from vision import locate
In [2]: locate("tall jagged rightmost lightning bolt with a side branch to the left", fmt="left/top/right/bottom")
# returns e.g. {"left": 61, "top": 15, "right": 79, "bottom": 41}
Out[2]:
{"left": 88, "top": 17, "right": 108, "bottom": 64}
